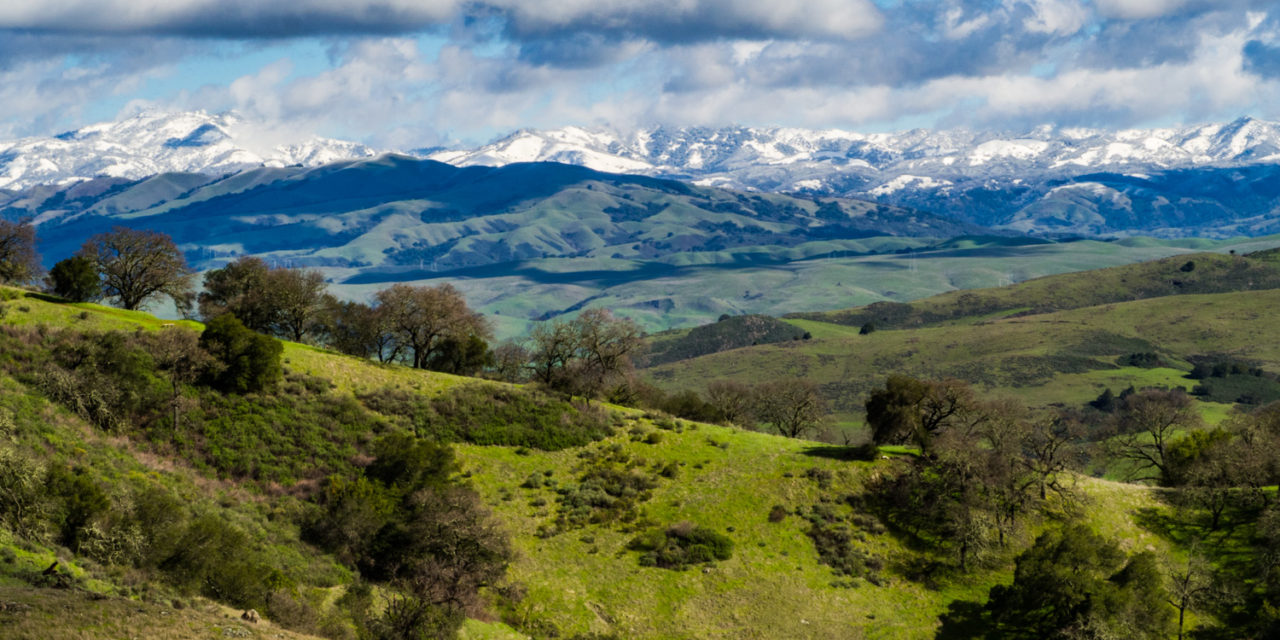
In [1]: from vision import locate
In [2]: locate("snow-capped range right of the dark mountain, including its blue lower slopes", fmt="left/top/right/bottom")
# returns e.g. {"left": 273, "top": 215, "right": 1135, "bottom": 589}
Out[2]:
{"left": 430, "top": 118, "right": 1280, "bottom": 236}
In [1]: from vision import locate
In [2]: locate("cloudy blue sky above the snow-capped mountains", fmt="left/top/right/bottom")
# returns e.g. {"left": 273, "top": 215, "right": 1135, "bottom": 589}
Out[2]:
{"left": 0, "top": 0, "right": 1280, "bottom": 148}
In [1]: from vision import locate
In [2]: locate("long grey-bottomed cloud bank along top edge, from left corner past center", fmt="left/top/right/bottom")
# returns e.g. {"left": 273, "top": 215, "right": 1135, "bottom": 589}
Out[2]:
{"left": 0, "top": 0, "right": 881, "bottom": 42}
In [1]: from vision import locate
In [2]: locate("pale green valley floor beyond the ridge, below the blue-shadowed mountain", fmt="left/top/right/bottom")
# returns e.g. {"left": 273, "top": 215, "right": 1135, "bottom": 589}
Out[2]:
{"left": 334, "top": 232, "right": 1280, "bottom": 338}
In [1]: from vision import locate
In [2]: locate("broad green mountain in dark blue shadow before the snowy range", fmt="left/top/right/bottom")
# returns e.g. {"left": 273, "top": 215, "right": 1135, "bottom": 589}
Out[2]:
{"left": 0, "top": 154, "right": 962, "bottom": 273}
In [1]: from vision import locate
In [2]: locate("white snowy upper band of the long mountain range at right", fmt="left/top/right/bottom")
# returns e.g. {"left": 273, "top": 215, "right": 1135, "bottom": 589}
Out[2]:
{"left": 429, "top": 118, "right": 1280, "bottom": 186}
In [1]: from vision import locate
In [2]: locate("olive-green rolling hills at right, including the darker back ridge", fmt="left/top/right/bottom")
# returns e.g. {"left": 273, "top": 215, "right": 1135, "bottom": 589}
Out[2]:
{"left": 645, "top": 252, "right": 1280, "bottom": 424}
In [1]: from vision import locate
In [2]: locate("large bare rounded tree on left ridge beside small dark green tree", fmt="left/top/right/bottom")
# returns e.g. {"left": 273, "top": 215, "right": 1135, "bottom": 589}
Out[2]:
{"left": 78, "top": 227, "right": 195, "bottom": 310}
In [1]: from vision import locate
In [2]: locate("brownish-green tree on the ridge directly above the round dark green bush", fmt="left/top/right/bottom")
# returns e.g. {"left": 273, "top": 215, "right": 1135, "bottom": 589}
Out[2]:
{"left": 198, "top": 256, "right": 278, "bottom": 333}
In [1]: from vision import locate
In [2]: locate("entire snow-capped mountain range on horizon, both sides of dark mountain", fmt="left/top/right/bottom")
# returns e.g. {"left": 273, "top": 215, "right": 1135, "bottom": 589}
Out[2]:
{"left": 0, "top": 111, "right": 1280, "bottom": 237}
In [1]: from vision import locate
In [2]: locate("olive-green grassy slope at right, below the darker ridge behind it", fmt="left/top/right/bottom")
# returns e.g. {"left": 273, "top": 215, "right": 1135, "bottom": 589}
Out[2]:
{"left": 648, "top": 289, "right": 1280, "bottom": 415}
